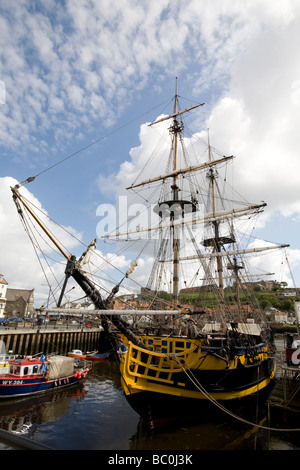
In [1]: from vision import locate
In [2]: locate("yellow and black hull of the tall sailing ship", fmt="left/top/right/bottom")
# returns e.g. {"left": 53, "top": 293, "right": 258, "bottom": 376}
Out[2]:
{"left": 120, "top": 337, "right": 276, "bottom": 423}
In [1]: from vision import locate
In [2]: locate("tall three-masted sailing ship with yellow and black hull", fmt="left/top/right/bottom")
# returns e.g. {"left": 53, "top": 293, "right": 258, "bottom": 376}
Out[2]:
{"left": 12, "top": 82, "right": 288, "bottom": 427}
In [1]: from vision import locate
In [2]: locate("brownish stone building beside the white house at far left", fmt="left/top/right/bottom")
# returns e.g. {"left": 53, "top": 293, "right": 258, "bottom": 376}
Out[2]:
{"left": 5, "top": 289, "right": 34, "bottom": 317}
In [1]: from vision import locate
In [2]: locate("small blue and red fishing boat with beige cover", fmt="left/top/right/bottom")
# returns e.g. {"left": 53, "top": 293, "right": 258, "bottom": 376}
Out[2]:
{"left": 0, "top": 355, "right": 88, "bottom": 399}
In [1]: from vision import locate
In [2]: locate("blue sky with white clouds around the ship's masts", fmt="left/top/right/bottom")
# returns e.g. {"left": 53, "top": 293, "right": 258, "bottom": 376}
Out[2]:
{"left": 0, "top": 0, "right": 300, "bottom": 306}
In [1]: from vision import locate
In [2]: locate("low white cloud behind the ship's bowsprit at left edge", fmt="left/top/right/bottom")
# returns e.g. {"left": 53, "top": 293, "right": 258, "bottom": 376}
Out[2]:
{"left": 0, "top": 177, "right": 81, "bottom": 302}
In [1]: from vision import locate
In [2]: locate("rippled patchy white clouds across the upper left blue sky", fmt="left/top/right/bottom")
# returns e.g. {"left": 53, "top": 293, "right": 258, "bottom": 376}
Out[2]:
{"left": 1, "top": 0, "right": 262, "bottom": 154}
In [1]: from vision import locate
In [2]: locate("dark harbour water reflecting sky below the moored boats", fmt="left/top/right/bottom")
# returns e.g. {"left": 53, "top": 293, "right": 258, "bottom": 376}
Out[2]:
{"left": 0, "top": 338, "right": 300, "bottom": 452}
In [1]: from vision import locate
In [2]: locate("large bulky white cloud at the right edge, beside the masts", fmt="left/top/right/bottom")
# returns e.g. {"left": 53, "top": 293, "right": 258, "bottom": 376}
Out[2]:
{"left": 204, "top": 18, "right": 300, "bottom": 215}
